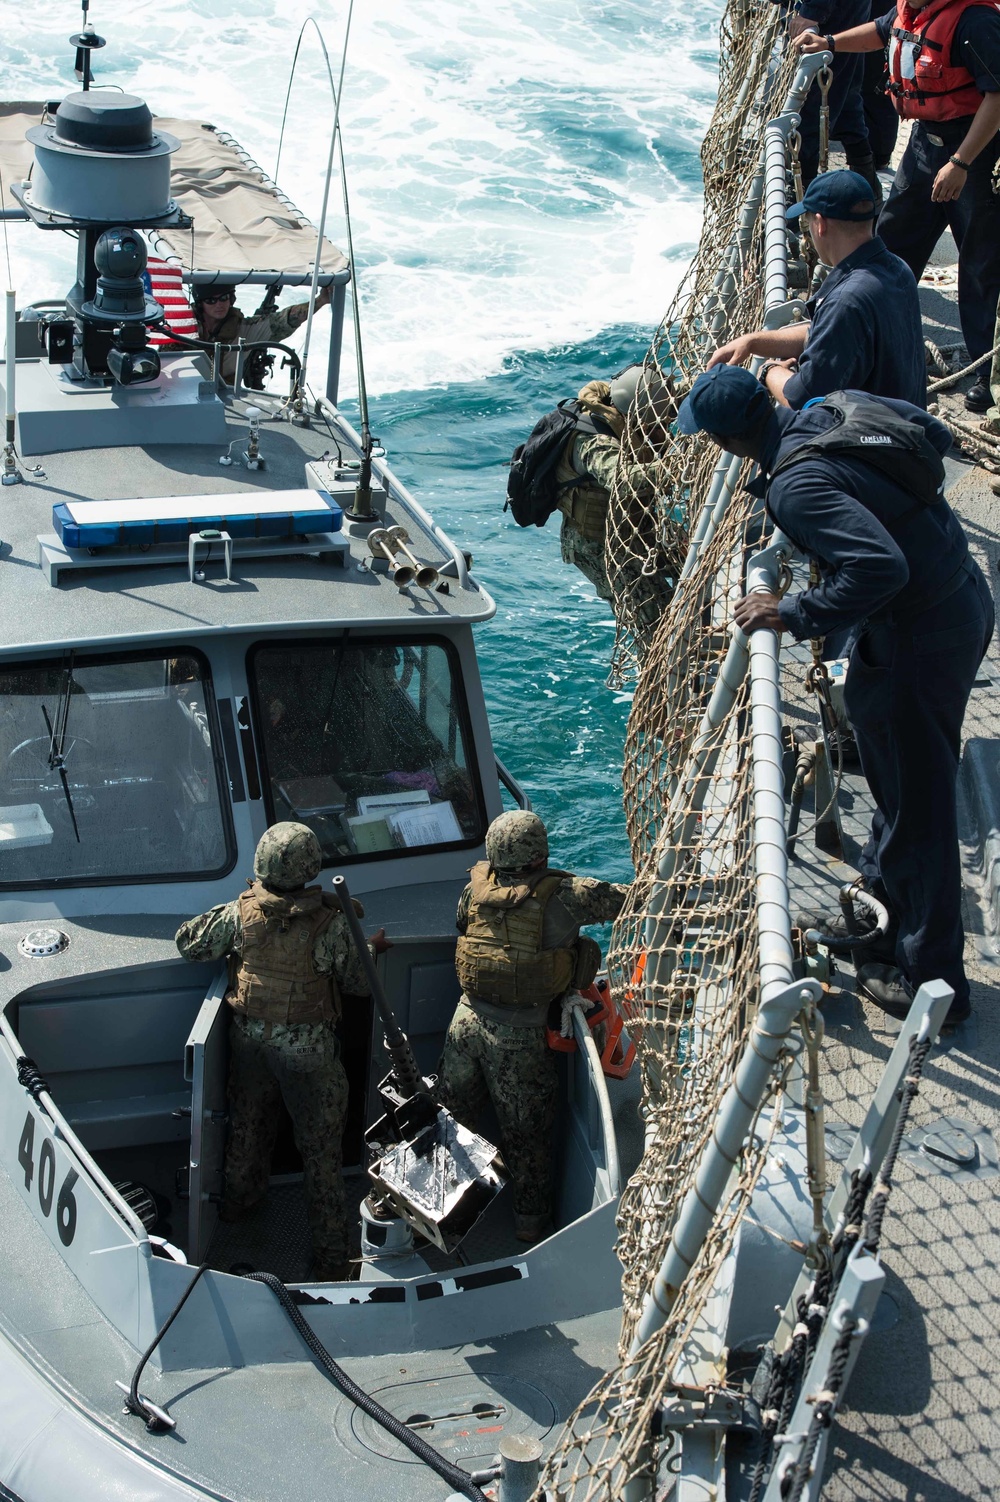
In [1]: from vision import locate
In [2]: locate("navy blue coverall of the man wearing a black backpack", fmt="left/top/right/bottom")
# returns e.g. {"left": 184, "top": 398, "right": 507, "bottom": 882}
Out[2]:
{"left": 751, "top": 394, "right": 994, "bottom": 1005}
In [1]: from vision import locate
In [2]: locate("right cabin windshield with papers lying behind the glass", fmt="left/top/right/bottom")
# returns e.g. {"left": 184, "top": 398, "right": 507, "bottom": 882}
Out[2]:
{"left": 249, "top": 635, "right": 485, "bottom": 865}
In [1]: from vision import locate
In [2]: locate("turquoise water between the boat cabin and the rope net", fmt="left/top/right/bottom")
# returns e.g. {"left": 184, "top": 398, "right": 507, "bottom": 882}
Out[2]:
{"left": 348, "top": 327, "right": 647, "bottom": 880}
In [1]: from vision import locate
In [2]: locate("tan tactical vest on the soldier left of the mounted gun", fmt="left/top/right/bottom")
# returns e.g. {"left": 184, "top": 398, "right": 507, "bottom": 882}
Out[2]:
{"left": 230, "top": 882, "right": 341, "bottom": 1024}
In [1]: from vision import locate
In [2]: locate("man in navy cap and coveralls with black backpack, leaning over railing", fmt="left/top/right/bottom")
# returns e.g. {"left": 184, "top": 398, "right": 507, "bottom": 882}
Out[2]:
{"left": 677, "top": 365, "right": 994, "bottom": 1026}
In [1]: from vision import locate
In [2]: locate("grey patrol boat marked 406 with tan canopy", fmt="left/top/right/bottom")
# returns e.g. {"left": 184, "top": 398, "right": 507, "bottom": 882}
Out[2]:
{"left": 0, "top": 14, "right": 651, "bottom": 1502}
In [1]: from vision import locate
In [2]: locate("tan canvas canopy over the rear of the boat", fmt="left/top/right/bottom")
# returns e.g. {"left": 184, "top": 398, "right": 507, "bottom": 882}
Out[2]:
{"left": 0, "top": 104, "right": 347, "bottom": 281}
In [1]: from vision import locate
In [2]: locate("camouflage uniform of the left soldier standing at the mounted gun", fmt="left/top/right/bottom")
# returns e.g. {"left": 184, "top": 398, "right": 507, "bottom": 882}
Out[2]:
{"left": 177, "top": 825, "right": 368, "bottom": 1280}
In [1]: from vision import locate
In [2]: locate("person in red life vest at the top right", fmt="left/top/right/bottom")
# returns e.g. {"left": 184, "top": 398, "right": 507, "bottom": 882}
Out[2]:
{"left": 797, "top": 0, "right": 1000, "bottom": 412}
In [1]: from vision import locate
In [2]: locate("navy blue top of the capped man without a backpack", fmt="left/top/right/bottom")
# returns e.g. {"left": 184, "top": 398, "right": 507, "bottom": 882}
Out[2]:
{"left": 782, "top": 231, "right": 926, "bottom": 407}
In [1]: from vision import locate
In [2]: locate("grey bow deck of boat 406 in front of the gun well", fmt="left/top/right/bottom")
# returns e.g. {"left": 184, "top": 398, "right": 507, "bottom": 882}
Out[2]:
{"left": 0, "top": 1117, "right": 619, "bottom": 1502}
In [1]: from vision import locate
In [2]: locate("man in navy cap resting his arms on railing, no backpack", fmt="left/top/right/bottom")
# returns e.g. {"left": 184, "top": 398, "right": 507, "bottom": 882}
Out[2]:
{"left": 709, "top": 173, "right": 926, "bottom": 409}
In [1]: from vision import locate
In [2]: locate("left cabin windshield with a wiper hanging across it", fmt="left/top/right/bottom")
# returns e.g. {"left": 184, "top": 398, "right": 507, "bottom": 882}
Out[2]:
{"left": 0, "top": 652, "right": 234, "bottom": 888}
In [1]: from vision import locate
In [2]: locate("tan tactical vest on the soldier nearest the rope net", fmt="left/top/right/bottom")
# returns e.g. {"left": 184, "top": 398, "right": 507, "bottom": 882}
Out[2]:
{"left": 455, "top": 861, "right": 576, "bottom": 1009}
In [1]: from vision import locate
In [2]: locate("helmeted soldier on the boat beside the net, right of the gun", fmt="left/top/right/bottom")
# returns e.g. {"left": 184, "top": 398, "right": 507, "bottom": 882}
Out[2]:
{"left": 438, "top": 813, "right": 628, "bottom": 1242}
